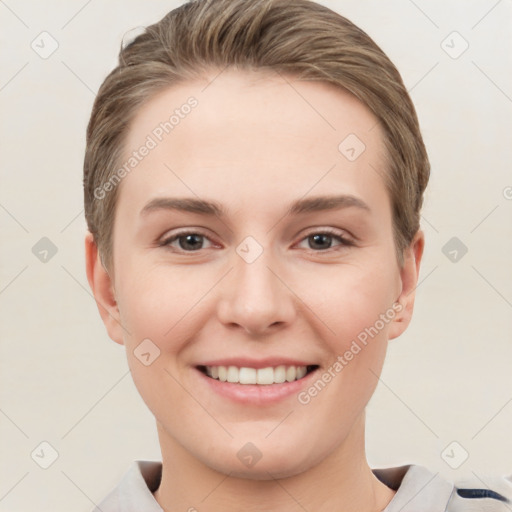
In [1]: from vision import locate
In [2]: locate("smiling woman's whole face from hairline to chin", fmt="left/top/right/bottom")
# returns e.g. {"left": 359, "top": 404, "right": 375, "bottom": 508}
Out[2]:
{"left": 89, "top": 71, "right": 421, "bottom": 478}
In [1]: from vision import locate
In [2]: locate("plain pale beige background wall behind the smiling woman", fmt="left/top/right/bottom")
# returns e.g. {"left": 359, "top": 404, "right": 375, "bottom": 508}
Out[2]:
{"left": 0, "top": 0, "right": 512, "bottom": 512}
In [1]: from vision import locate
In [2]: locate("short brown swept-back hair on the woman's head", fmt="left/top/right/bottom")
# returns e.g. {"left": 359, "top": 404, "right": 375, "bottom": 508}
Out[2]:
{"left": 84, "top": 0, "right": 430, "bottom": 269}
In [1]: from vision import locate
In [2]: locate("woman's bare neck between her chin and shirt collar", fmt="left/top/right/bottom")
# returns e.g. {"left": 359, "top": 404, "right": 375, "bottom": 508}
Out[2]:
{"left": 154, "top": 412, "right": 395, "bottom": 512}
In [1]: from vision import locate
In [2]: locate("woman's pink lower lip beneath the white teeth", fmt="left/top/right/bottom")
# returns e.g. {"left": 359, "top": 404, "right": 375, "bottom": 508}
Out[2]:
{"left": 196, "top": 368, "right": 318, "bottom": 405}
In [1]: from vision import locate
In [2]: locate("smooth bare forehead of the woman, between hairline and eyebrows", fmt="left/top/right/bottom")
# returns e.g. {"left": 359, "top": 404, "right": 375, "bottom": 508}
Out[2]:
{"left": 116, "top": 70, "right": 385, "bottom": 218}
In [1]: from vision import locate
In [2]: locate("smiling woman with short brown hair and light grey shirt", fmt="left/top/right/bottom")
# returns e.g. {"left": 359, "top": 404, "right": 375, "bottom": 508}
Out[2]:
{"left": 84, "top": 0, "right": 512, "bottom": 512}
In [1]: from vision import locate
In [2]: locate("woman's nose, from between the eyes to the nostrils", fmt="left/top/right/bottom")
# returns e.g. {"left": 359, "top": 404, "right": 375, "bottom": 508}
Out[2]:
{"left": 217, "top": 244, "right": 296, "bottom": 336}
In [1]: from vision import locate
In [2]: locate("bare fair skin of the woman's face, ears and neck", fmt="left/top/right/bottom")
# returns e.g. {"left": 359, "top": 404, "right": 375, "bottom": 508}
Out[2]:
{"left": 85, "top": 70, "right": 424, "bottom": 512}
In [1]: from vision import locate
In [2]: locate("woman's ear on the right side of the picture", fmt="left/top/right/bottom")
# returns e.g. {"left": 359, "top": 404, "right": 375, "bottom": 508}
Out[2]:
{"left": 389, "top": 230, "right": 425, "bottom": 340}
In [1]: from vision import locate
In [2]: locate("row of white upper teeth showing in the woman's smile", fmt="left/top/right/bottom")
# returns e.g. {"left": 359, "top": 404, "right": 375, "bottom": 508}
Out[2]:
{"left": 202, "top": 365, "right": 307, "bottom": 385}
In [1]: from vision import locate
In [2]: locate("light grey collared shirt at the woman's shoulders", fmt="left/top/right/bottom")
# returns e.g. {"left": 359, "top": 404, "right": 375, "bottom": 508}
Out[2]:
{"left": 93, "top": 460, "right": 512, "bottom": 512}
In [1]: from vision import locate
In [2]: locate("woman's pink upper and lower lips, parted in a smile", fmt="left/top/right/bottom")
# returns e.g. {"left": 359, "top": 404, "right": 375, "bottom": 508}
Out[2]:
{"left": 194, "top": 359, "right": 319, "bottom": 406}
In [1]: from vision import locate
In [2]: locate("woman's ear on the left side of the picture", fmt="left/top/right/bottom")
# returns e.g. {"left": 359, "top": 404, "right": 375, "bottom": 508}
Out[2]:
{"left": 85, "top": 231, "right": 124, "bottom": 345}
